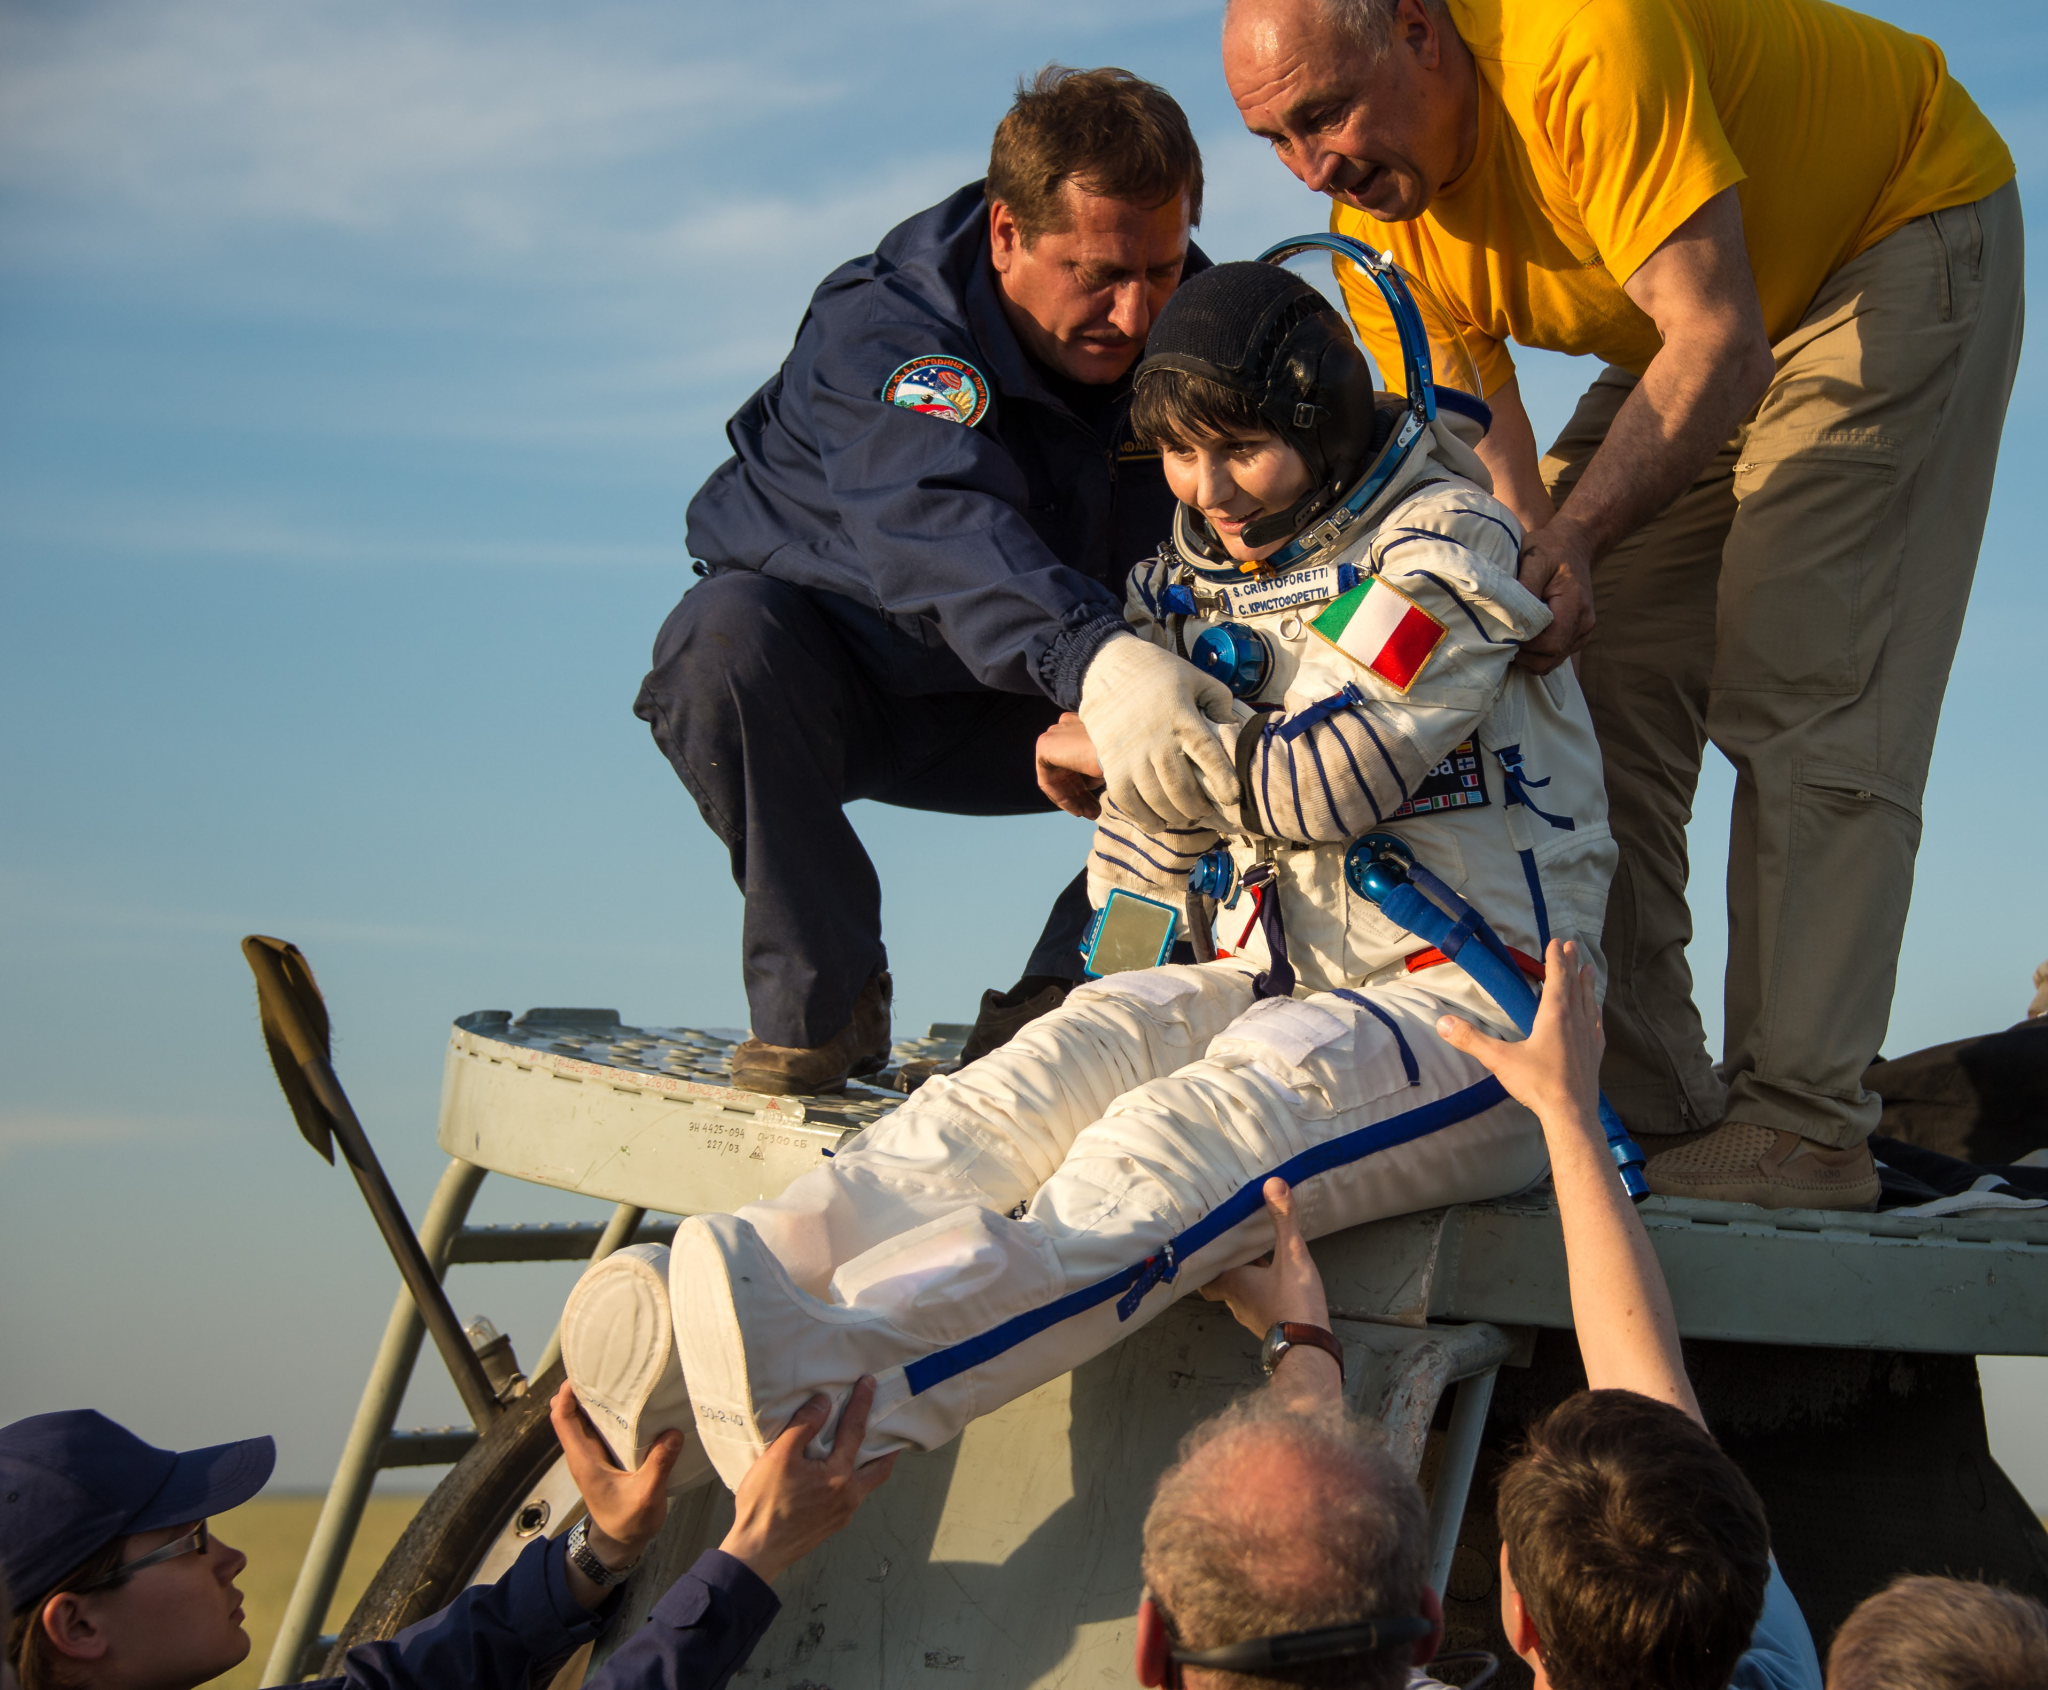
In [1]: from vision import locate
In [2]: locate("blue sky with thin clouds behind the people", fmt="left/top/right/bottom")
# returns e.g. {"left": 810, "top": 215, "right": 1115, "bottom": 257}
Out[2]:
{"left": 12, "top": 0, "right": 2048, "bottom": 1499}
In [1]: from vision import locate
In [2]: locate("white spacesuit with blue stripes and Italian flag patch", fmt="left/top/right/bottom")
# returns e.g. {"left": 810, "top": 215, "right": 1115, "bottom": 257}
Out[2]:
{"left": 670, "top": 264, "right": 1614, "bottom": 1483}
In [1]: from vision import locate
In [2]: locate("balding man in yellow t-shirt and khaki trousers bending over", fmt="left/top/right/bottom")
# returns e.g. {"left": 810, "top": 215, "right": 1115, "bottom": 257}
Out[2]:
{"left": 1223, "top": 0, "right": 2023, "bottom": 1209}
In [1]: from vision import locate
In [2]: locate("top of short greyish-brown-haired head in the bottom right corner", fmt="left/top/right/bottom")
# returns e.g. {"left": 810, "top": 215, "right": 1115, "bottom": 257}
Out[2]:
{"left": 1827, "top": 1577, "right": 2048, "bottom": 1690}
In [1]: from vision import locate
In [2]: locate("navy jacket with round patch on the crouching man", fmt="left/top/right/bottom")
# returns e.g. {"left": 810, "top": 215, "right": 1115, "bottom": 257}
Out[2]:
{"left": 688, "top": 182, "right": 1208, "bottom": 709}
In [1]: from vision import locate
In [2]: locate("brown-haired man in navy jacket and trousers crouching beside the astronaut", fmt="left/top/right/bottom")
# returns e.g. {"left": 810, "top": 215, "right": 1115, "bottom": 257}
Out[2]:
{"left": 635, "top": 68, "right": 1229, "bottom": 1092}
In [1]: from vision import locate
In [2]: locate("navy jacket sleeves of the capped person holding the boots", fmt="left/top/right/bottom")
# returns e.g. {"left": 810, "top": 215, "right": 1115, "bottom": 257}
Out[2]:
{"left": 299, "top": 1536, "right": 782, "bottom": 1690}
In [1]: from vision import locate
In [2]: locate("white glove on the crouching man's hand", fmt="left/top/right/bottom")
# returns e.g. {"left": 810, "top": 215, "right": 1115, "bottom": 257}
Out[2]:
{"left": 1081, "top": 635, "right": 1237, "bottom": 830}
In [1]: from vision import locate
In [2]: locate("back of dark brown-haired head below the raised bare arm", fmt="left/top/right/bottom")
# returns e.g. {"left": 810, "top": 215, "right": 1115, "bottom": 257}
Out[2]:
{"left": 1499, "top": 1391, "right": 1769, "bottom": 1690}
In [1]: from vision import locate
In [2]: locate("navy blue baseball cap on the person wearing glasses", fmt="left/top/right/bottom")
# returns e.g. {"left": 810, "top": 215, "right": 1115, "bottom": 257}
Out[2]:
{"left": 0, "top": 1409, "right": 276, "bottom": 1612}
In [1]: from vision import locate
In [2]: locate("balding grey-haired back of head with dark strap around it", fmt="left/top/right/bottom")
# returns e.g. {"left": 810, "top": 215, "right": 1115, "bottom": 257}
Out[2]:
{"left": 1145, "top": 1391, "right": 1427, "bottom": 1690}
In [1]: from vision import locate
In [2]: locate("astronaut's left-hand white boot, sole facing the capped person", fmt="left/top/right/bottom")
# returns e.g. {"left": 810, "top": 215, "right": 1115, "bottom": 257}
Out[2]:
{"left": 561, "top": 1243, "right": 711, "bottom": 1495}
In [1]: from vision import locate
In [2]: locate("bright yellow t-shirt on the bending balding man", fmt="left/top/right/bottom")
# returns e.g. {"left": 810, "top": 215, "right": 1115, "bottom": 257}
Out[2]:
{"left": 1331, "top": 0, "right": 2013, "bottom": 393}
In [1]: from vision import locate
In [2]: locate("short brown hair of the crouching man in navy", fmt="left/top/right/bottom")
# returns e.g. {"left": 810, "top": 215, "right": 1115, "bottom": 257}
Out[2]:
{"left": 987, "top": 66, "right": 1202, "bottom": 244}
